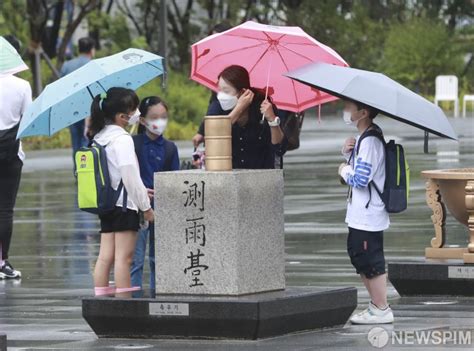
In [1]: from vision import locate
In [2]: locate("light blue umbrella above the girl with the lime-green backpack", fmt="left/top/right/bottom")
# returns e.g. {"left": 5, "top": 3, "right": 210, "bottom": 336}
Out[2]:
{"left": 17, "top": 49, "right": 164, "bottom": 138}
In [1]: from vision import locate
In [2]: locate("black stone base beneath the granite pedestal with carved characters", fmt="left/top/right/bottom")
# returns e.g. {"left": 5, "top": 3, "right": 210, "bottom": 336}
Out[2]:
{"left": 82, "top": 287, "right": 357, "bottom": 339}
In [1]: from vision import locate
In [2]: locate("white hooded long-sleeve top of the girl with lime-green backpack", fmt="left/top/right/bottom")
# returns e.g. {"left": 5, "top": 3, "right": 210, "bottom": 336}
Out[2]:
{"left": 94, "top": 125, "right": 151, "bottom": 211}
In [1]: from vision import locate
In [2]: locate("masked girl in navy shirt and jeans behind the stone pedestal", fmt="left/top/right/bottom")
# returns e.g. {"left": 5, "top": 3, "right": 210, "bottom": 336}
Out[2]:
{"left": 131, "top": 96, "right": 179, "bottom": 291}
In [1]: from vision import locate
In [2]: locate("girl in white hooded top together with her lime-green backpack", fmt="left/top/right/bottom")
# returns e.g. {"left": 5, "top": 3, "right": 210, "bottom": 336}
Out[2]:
{"left": 76, "top": 88, "right": 154, "bottom": 297}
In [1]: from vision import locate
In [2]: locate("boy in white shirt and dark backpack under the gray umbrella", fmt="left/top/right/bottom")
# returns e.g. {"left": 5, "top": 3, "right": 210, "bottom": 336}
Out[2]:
{"left": 338, "top": 100, "right": 407, "bottom": 324}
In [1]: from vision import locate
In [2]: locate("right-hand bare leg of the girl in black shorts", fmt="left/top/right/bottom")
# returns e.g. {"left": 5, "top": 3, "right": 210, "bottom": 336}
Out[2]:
{"left": 114, "top": 230, "right": 137, "bottom": 296}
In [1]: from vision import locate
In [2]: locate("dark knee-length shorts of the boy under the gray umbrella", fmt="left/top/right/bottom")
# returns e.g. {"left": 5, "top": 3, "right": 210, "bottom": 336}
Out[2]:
{"left": 347, "top": 227, "right": 385, "bottom": 279}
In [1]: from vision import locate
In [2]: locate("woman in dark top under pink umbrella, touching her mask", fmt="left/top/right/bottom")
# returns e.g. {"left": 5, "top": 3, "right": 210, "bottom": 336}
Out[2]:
{"left": 192, "top": 65, "right": 288, "bottom": 169}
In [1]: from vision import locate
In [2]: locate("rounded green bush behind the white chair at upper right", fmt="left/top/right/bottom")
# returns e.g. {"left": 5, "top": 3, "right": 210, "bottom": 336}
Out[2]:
{"left": 380, "top": 19, "right": 462, "bottom": 94}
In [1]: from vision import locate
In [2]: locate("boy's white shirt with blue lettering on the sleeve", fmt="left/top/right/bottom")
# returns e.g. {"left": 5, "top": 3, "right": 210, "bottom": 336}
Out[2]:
{"left": 341, "top": 136, "right": 390, "bottom": 232}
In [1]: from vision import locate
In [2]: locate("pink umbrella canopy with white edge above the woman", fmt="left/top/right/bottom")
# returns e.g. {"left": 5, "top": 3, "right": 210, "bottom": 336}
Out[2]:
{"left": 191, "top": 21, "right": 347, "bottom": 112}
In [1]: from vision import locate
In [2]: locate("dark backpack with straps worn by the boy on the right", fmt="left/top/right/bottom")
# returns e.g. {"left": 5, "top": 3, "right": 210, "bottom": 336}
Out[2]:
{"left": 351, "top": 125, "right": 410, "bottom": 213}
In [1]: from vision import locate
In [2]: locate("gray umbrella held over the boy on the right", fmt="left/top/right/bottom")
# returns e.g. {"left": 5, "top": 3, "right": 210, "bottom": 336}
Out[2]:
{"left": 285, "top": 63, "right": 457, "bottom": 140}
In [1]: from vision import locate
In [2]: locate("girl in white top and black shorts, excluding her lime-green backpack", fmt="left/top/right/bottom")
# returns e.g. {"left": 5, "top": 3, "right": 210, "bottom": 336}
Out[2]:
{"left": 89, "top": 88, "right": 154, "bottom": 297}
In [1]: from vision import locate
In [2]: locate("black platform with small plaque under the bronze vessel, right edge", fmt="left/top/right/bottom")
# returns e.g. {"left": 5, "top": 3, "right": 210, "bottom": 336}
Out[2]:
{"left": 388, "top": 261, "right": 474, "bottom": 296}
